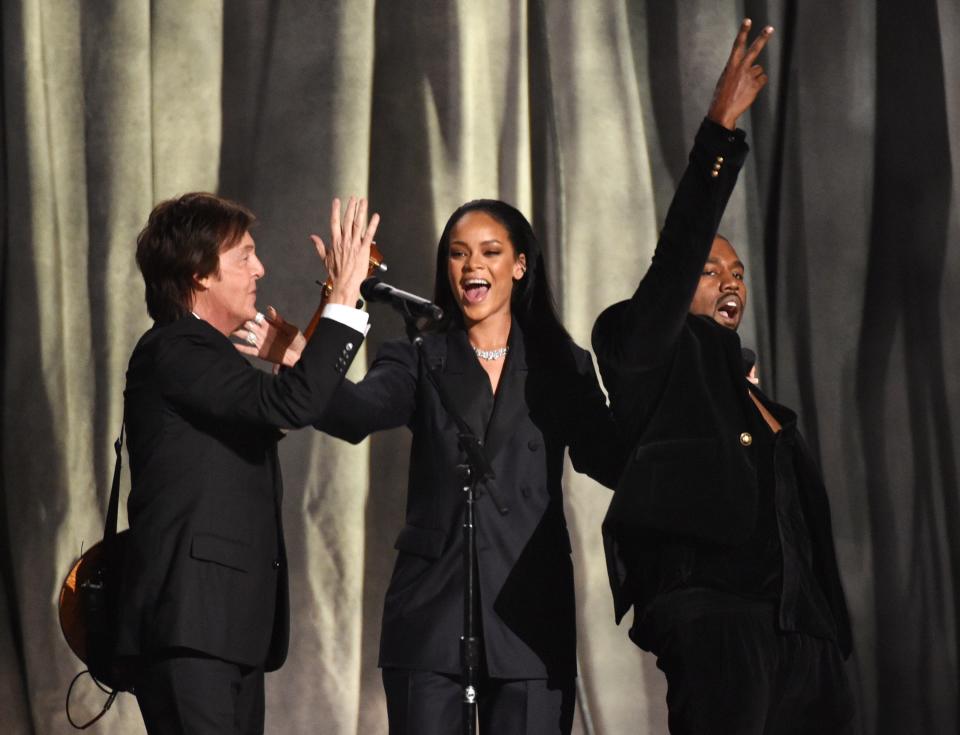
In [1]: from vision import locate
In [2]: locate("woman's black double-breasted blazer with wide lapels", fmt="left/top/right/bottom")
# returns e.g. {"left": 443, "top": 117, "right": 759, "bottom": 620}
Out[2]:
{"left": 318, "top": 321, "right": 623, "bottom": 679}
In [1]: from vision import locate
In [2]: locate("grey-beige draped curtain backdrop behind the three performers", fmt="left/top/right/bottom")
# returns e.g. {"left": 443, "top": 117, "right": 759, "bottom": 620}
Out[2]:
{"left": 0, "top": 0, "right": 960, "bottom": 735}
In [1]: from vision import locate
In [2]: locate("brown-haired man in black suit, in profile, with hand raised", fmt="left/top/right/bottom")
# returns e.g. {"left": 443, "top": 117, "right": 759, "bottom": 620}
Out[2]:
{"left": 117, "top": 194, "right": 379, "bottom": 735}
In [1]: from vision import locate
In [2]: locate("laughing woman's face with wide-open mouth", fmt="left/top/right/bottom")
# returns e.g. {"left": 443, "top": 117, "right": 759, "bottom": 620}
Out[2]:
{"left": 447, "top": 210, "right": 526, "bottom": 326}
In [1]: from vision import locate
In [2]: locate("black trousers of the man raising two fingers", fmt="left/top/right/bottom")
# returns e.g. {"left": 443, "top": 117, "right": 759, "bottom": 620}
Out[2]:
{"left": 653, "top": 605, "right": 854, "bottom": 735}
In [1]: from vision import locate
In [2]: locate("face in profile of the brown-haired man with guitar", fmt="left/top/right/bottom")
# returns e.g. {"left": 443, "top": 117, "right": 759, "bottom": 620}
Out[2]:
{"left": 197, "top": 232, "right": 265, "bottom": 333}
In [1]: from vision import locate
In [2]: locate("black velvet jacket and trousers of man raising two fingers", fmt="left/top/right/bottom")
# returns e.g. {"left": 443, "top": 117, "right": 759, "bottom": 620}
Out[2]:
{"left": 593, "top": 121, "right": 851, "bottom": 733}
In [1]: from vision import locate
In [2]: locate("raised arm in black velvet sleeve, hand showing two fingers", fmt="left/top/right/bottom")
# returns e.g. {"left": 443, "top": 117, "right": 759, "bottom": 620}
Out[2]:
{"left": 593, "top": 19, "right": 773, "bottom": 371}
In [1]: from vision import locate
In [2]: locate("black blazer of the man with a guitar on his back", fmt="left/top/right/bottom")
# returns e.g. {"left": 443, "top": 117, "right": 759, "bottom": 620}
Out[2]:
{"left": 117, "top": 316, "right": 363, "bottom": 670}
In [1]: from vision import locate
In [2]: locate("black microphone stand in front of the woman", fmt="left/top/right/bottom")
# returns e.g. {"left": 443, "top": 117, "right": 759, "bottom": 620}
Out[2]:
{"left": 395, "top": 304, "right": 508, "bottom": 735}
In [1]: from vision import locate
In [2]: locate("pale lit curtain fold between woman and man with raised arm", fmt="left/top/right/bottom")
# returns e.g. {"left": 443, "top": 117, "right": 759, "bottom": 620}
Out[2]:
{"left": 544, "top": 3, "right": 665, "bottom": 733}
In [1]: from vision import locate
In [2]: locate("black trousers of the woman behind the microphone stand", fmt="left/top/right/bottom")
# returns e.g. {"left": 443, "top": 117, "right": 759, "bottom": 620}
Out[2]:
{"left": 383, "top": 669, "right": 576, "bottom": 735}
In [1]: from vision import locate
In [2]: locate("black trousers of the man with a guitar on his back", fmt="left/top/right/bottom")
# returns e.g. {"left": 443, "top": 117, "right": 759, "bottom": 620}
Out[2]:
{"left": 136, "top": 649, "right": 264, "bottom": 735}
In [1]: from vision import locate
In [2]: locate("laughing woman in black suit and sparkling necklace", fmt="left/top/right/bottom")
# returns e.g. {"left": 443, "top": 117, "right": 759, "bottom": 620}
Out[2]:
{"left": 249, "top": 200, "right": 621, "bottom": 735}
